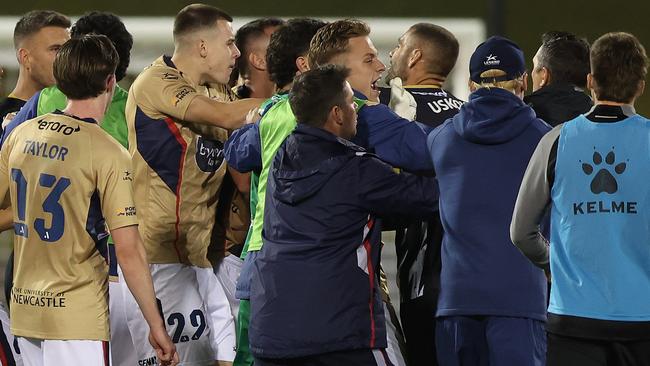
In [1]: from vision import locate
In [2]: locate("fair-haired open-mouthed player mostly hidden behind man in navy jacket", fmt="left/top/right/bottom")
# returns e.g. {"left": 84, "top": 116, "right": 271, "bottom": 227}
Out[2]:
{"left": 227, "top": 20, "right": 431, "bottom": 364}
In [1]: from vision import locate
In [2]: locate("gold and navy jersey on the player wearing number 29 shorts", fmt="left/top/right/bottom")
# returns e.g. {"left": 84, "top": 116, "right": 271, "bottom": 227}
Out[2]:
{"left": 126, "top": 56, "right": 228, "bottom": 267}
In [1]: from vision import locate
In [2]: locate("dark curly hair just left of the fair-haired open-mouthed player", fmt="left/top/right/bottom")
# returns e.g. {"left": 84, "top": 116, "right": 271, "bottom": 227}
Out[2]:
{"left": 266, "top": 18, "right": 327, "bottom": 89}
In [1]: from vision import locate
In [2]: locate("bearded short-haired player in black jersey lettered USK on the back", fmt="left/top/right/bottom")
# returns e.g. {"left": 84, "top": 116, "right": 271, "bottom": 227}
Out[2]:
{"left": 379, "top": 23, "right": 463, "bottom": 366}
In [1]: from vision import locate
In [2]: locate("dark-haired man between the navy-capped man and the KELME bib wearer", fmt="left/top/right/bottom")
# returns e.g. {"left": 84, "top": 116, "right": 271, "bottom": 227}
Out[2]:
{"left": 524, "top": 32, "right": 593, "bottom": 126}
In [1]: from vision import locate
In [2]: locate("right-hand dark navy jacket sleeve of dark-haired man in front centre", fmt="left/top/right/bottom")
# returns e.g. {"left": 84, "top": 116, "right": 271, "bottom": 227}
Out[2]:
{"left": 357, "top": 156, "right": 439, "bottom": 216}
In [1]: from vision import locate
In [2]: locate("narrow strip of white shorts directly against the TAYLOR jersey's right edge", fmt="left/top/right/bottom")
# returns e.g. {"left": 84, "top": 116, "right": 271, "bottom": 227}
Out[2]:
{"left": 108, "top": 267, "right": 138, "bottom": 366}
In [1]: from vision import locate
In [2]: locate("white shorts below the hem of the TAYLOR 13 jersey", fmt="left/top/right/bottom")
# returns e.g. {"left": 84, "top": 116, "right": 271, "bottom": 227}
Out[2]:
{"left": 17, "top": 337, "right": 110, "bottom": 366}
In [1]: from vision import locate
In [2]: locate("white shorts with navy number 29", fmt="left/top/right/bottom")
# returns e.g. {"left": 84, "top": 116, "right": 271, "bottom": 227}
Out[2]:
{"left": 120, "top": 263, "right": 216, "bottom": 366}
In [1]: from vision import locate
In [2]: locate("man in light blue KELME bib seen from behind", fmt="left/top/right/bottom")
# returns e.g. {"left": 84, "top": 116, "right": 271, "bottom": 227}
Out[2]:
{"left": 510, "top": 33, "right": 650, "bottom": 366}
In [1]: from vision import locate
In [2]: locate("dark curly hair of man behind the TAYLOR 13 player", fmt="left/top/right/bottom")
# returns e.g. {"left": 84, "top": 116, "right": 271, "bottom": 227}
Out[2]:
{"left": 70, "top": 11, "right": 133, "bottom": 81}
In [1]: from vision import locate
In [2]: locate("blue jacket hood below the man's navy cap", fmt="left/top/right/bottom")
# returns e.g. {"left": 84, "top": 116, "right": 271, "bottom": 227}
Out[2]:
{"left": 452, "top": 88, "right": 537, "bottom": 145}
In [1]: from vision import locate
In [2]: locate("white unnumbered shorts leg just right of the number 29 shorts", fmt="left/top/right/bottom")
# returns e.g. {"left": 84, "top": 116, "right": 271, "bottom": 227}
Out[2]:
{"left": 193, "top": 267, "right": 237, "bottom": 362}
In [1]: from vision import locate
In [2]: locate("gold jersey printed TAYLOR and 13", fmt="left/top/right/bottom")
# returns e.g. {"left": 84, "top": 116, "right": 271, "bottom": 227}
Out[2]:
{"left": 0, "top": 112, "right": 137, "bottom": 340}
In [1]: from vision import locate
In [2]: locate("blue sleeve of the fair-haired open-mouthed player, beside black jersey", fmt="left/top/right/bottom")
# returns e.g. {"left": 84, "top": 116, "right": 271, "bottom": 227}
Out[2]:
{"left": 352, "top": 104, "right": 433, "bottom": 171}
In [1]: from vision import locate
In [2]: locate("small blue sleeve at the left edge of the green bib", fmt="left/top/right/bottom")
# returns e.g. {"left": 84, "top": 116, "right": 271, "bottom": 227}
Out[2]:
{"left": 224, "top": 123, "right": 262, "bottom": 173}
